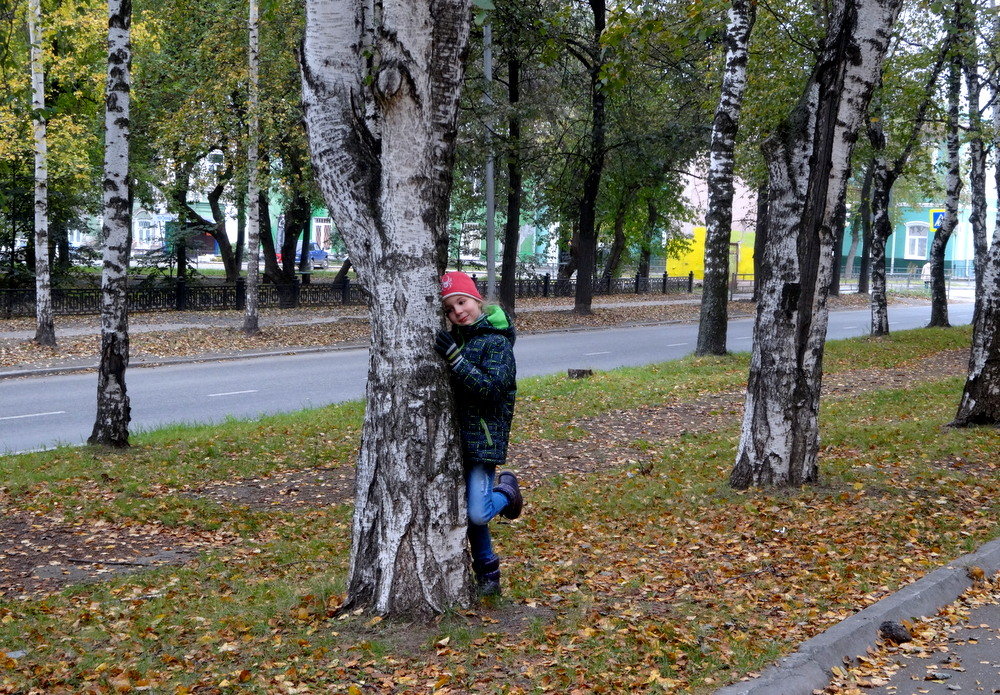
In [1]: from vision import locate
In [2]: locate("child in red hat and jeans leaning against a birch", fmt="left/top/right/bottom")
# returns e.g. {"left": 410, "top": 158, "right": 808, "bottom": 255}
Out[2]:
{"left": 434, "top": 272, "right": 522, "bottom": 596}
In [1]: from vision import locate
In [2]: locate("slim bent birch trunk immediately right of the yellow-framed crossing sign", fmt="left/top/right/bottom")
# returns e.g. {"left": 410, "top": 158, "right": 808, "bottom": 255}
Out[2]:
{"left": 927, "top": 52, "right": 962, "bottom": 327}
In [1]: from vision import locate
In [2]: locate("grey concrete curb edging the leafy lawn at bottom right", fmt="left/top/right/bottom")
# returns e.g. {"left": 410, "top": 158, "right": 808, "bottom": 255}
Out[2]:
{"left": 715, "top": 539, "right": 1000, "bottom": 695}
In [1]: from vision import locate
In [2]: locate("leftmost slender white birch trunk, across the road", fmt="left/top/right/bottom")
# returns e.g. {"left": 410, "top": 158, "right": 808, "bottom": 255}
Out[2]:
{"left": 28, "top": 0, "right": 56, "bottom": 347}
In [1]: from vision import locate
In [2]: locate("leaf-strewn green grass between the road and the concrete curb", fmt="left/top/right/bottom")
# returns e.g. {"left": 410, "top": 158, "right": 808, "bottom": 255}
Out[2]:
{"left": 0, "top": 329, "right": 1000, "bottom": 693}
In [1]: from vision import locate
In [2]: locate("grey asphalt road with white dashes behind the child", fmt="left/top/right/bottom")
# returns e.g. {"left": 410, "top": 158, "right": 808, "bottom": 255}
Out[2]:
{"left": 0, "top": 304, "right": 973, "bottom": 453}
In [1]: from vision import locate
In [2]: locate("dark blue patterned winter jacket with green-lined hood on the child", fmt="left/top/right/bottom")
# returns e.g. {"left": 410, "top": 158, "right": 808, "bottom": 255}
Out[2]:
{"left": 451, "top": 306, "right": 517, "bottom": 467}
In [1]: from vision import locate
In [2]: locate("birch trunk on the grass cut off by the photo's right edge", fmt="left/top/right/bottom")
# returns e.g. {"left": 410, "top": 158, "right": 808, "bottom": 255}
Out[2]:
{"left": 951, "top": 3, "right": 1000, "bottom": 427}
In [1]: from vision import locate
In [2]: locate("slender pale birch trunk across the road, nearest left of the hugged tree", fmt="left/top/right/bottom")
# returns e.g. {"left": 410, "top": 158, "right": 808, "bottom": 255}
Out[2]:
{"left": 243, "top": 0, "right": 267, "bottom": 335}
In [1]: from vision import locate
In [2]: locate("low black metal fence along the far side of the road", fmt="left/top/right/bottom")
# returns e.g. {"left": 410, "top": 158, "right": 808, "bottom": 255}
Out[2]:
{"left": 0, "top": 274, "right": 694, "bottom": 318}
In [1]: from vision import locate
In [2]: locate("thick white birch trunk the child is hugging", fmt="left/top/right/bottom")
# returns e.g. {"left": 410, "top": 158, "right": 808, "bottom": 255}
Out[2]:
{"left": 302, "top": 0, "right": 472, "bottom": 619}
